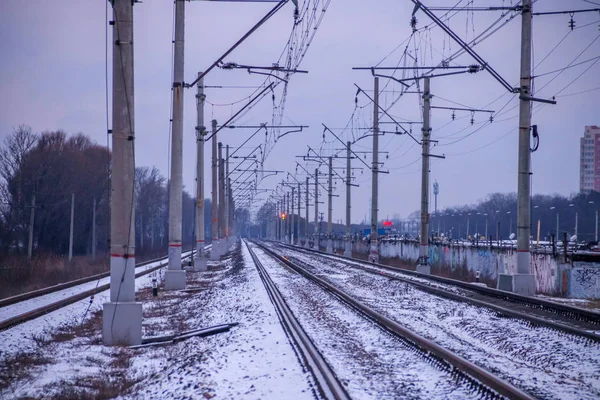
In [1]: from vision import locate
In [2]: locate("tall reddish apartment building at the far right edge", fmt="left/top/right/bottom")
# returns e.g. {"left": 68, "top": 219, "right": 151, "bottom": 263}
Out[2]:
{"left": 579, "top": 125, "right": 600, "bottom": 192}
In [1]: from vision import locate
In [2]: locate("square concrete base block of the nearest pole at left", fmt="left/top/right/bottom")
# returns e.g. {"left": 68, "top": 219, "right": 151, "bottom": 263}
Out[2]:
{"left": 102, "top": 302, "right": 142, "bottom": 346}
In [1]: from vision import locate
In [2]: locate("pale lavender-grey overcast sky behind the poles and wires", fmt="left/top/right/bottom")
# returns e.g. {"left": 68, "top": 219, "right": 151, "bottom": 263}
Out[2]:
{"left": 0, "top": 0, "right": 600, "bottom": 222}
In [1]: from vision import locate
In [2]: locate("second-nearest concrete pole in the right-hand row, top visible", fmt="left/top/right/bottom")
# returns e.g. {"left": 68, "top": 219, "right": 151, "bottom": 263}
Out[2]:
{"left": 417, "top": 78, "right": 431, "bottom": 274}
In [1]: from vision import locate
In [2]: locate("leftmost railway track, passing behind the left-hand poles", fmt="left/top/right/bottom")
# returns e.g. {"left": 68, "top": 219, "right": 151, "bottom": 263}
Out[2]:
{"left": 0, "top": 246, "right": 210, "bottom": 331}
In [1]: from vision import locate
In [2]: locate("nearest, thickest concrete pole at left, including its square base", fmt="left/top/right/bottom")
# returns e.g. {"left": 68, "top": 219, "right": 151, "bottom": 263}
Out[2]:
{"left": 102, "top": 0, "right": 142, "bottom": 346}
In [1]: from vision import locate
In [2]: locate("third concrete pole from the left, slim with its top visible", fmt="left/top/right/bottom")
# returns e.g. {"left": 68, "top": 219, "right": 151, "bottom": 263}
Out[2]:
{"left": 194, "top": 72, "right": 208, "bottom": 271}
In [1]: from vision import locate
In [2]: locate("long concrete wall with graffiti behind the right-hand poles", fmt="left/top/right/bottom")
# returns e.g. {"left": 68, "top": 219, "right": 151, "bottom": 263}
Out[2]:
{"left": 334, "top": 240, "right": 600, "bottom": 298}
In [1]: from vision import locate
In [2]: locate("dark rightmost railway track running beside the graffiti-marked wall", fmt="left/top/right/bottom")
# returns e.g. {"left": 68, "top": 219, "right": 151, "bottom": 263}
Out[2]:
{"left": 275, "top": 243, "right": 600, "bottom": 342}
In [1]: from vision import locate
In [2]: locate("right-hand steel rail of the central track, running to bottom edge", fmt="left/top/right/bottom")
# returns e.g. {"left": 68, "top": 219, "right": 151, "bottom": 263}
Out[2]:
{"left": 256, "top": 243, "right": 533, "bottom": 400}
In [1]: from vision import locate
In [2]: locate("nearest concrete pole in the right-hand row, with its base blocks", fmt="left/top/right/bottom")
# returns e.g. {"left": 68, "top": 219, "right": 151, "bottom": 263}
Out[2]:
{"left": 498, "top": 0, "right": 535, "bottom": 296}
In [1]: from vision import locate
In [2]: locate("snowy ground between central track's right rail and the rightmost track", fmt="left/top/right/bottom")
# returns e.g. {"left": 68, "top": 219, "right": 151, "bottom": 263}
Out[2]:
{"left": 278, "top": 247, "right": 600, "bottom": 399}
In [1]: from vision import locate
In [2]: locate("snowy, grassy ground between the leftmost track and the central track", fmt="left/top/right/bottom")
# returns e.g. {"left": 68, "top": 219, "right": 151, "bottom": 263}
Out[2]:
{"left": 0, "top": 242, "right": 315, "bottom": 400}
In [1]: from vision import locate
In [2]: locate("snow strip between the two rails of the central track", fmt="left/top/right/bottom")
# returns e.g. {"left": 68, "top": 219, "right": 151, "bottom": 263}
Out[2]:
{"left": 248, "top": 242, "right": 480, "bottom": 399}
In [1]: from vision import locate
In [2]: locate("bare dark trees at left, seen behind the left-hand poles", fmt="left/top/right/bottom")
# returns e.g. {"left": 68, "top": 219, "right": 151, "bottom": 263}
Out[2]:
{"left": 0, "top": 125, "right": 225, "bottom": 255}
